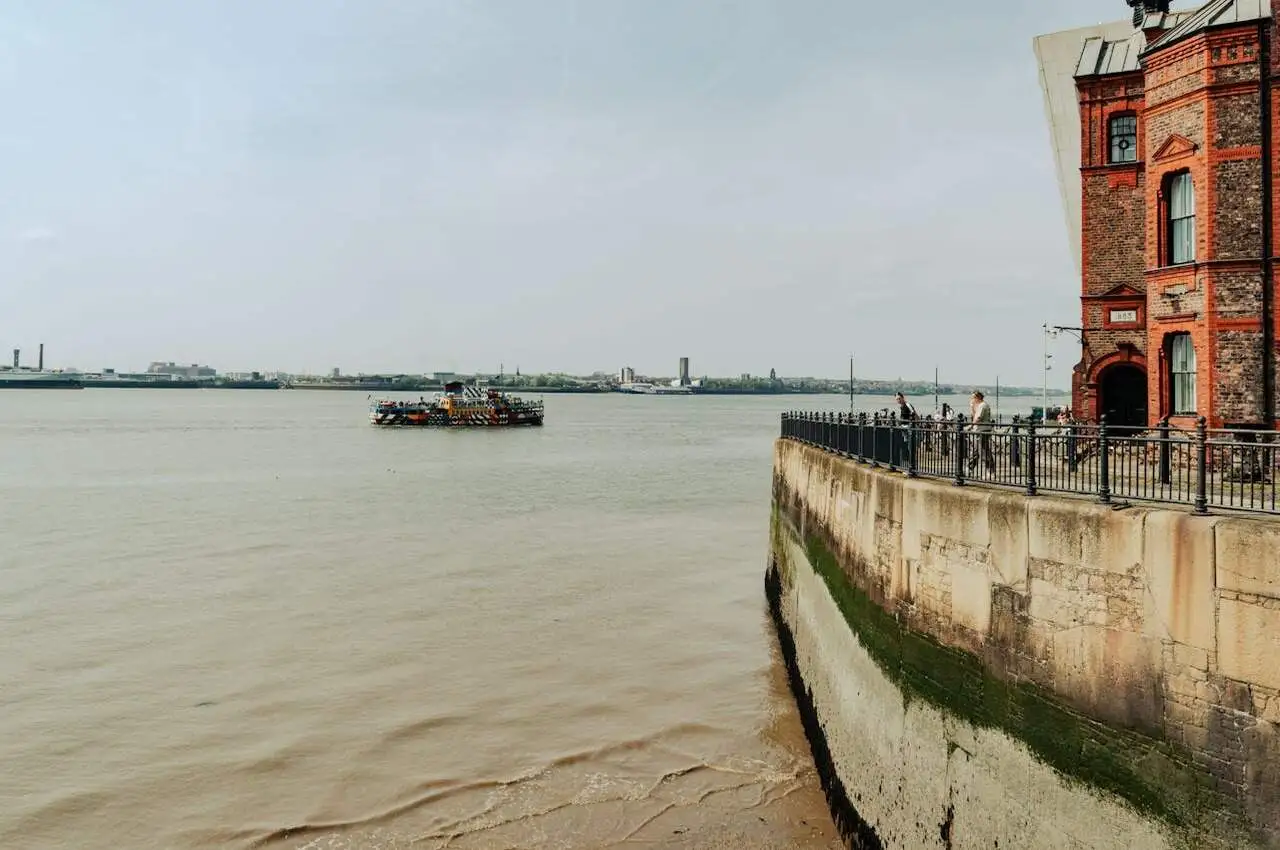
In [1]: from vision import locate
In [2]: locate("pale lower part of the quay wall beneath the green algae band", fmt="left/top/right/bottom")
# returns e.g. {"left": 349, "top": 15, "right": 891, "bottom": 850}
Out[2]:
{"left": 768, "top": 522, "right": 1182, "bottom": 850}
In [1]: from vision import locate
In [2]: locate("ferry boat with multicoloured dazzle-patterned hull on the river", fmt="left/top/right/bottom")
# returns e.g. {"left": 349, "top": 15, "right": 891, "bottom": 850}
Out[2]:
{"left": 369, "top": 383, "right": 543, "bottom": 428}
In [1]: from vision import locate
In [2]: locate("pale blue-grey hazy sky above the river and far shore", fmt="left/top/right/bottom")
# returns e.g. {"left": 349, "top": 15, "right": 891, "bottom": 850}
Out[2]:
{"left": 0, "top": 0, "right": 1129, "bottom": 387}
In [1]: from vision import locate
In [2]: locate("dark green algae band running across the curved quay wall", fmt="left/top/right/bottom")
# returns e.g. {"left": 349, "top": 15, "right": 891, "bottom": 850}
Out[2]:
{"left": 772, "top": 503, "right": 1244, "bottom": 832}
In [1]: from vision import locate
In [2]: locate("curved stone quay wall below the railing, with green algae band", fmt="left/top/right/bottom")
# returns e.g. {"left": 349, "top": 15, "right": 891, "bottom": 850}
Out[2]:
{"left": 767, "top": 439, "right": 1280, "bottom": 850}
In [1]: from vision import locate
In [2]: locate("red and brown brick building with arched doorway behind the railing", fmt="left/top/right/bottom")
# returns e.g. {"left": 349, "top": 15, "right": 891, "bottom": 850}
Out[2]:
{"left": 1073, "top": 0, "right": 1280, "bottom": 428}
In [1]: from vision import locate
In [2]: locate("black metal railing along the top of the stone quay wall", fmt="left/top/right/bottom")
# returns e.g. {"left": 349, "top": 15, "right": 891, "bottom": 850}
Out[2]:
{"left": 782, "top": 411, "right": 1280, "bottom": 513}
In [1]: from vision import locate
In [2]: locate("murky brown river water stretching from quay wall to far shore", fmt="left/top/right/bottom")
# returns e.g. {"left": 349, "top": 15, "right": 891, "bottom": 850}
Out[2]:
{"left": 0, "top": 389, "right": 1059, "bottom": 850}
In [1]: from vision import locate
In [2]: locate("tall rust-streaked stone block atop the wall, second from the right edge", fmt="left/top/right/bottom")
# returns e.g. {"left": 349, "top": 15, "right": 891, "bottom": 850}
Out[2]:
{"left": 1143, "top": 511, "right": 1219, "bottom": 652}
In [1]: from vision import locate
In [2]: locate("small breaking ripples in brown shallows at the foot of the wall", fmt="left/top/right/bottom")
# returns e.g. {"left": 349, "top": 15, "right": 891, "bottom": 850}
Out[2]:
{"left": 239, "top": 726, "right": 840, "bottom": 850}
